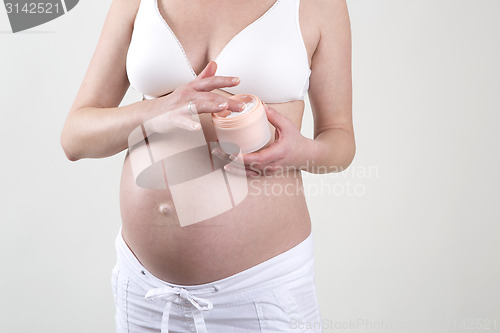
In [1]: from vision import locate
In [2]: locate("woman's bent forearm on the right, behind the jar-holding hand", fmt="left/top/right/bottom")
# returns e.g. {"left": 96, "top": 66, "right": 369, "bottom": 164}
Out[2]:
{"left": 303, "top": 128, "right": 356, "bottom": 174}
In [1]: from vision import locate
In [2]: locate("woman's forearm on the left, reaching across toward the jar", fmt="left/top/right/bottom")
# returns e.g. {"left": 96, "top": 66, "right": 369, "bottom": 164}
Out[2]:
{"left": 61, "top": 100, "right": 157, "bottom": 161}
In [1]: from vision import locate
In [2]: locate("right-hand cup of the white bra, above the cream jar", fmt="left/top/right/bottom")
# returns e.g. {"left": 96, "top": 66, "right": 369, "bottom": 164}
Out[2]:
{"left": 212, "top": 0, "right": 309, "bottom": 103}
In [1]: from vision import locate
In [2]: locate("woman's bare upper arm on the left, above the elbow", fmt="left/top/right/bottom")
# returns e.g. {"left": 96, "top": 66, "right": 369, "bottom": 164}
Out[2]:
{"left": 71, "top": 0, "right": 140, "bottom": 110}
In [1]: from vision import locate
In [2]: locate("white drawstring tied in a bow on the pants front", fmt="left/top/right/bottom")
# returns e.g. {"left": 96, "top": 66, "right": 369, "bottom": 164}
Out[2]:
{"left": 144, "top": 286, "right": 217, "bottom": 333}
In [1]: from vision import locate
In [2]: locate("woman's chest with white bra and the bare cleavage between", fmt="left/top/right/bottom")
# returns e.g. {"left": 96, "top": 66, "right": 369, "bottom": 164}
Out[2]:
{"left": 127, "top": 0, "right": 315, "bottom": 103}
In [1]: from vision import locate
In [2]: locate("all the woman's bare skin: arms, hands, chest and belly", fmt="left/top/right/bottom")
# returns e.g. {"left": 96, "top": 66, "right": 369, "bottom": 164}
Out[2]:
{"left": 61, "top": 0, "right": 355, "bottom": 284}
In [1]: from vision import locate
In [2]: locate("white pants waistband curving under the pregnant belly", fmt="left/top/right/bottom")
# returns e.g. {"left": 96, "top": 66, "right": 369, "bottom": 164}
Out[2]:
{"left": 115, "top": 226, "right": 314, "bottom": 297}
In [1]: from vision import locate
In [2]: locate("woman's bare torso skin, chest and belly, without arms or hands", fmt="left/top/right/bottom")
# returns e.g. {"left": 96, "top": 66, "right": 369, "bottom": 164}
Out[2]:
{"left": 120, "top": 0, "right": 319, "bottom": 284}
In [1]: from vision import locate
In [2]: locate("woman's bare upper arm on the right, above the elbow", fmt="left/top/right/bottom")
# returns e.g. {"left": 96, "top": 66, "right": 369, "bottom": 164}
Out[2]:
{"left": 309, "top": 0, "right": 353, "bottom": 137}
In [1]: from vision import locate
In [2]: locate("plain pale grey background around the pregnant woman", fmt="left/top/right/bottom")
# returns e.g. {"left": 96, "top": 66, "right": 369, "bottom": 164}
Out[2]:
{"left": 0, "top": 0, "right": 500, "bottom": 333}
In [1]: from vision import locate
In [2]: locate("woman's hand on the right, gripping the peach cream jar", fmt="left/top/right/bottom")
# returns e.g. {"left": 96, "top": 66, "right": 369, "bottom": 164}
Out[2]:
{"left": 213, "top": 104, "right": 313, "bottom": 177}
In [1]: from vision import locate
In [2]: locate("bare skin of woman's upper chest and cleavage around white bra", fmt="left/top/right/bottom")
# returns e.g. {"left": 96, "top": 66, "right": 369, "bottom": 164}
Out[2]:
{"left": 157, "top": 0, "right": 317, "bottom": 74}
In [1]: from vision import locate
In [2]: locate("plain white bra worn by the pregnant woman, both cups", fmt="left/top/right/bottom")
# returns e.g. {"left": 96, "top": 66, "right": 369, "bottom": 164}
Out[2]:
{"left": 126, "top": 0, "right": 311, "bottom": 103}
